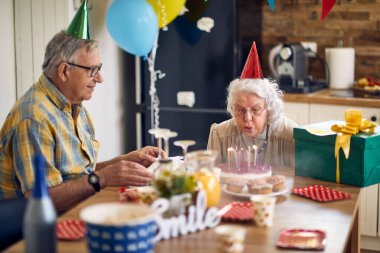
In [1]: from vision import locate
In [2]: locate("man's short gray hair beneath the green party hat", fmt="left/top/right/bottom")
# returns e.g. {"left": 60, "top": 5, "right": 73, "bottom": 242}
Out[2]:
{"left": 42, "top": 31, "right": 98, "bottom": 77}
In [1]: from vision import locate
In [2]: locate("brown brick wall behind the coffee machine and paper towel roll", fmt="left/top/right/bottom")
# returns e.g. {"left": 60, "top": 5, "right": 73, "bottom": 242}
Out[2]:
{"left": 238, "top": 0, "right": 380, "bottom": 79}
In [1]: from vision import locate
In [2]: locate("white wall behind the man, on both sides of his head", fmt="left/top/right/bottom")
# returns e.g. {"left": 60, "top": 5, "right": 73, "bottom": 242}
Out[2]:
{"left": 0, "top": 0, "right": 123, "bottom": 160}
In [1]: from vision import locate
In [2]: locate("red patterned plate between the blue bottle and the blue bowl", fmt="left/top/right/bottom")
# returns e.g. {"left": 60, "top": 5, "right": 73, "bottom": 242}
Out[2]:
{"left": 56, "top": 220, "right": 86, "bottom": 240}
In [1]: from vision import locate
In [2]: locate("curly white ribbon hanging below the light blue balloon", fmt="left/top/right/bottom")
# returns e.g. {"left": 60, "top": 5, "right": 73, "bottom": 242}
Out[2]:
{"left": 147, "top": 31, "right": 165, "bottom": 128}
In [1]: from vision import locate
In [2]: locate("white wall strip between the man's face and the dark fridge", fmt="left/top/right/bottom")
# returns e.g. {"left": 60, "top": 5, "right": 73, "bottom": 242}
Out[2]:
{"left": 85, "top": 0, "right": 124, "bottom": 160}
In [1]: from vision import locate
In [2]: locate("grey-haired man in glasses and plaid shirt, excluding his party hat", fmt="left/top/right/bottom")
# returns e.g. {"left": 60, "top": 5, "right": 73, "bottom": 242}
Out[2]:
{"left": 0, "top": 3, "right": 159, "bottom": 212}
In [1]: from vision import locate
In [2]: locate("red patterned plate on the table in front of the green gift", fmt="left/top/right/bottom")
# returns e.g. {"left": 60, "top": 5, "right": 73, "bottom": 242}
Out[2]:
{"left": 292, "top": 185, "right": 351, "bottom": 202}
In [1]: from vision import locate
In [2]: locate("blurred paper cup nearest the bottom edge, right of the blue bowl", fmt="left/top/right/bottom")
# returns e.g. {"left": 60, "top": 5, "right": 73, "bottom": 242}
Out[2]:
{"left": 214, "top": 225, "right": 247, "bottom": 253}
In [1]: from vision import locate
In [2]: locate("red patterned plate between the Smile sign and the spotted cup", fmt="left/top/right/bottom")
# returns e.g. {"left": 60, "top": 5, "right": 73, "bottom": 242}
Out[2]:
{"left": 218, "top": 201, "right": 253, "bottom": 222}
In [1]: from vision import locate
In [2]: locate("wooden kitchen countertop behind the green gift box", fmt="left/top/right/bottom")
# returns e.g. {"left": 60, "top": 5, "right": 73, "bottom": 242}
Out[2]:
{"left": 284, "top": 89, "right": 380, "bottom": 108}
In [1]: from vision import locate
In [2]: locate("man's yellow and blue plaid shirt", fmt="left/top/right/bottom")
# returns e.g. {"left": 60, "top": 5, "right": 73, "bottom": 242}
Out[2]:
{"left": 0, "top": 75, "right": 99, "bottom": 199}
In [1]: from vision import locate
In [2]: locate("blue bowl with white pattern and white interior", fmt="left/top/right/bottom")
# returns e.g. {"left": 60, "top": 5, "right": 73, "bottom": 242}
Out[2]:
{"left": 80, "top": 203, "right": 157, "bottom": 253}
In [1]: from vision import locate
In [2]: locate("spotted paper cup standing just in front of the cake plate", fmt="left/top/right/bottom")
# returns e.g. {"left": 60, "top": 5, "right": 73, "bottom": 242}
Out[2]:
{"left": 251, "top": 196, "right": 276, "bottom": 227}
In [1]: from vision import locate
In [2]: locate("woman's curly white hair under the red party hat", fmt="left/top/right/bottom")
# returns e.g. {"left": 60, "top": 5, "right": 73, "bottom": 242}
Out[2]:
{"left": 226, "top": 78, "right": 284, "bottom": 130}
